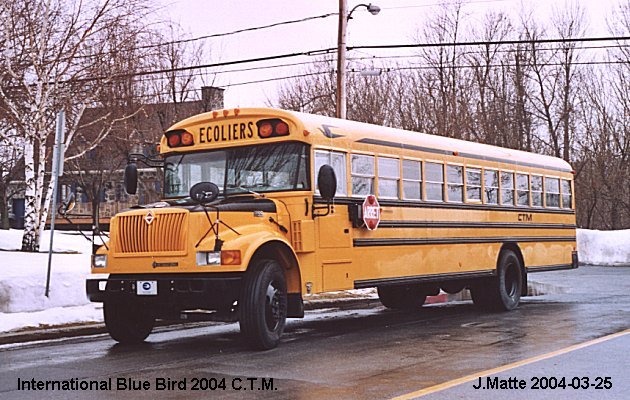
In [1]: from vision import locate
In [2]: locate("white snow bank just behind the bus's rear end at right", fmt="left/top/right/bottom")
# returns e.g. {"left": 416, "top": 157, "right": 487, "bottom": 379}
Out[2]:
{"left": 577, "top": 229, "right": 630, "bottom": 265}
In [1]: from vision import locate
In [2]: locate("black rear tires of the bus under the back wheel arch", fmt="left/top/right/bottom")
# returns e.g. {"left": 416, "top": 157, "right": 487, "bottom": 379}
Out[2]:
{"left": 470, "top": 250, "right": 523, "bottom": 311}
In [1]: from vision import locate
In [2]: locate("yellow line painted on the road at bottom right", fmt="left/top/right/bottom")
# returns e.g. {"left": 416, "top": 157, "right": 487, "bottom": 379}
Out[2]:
{"left": 391, "top": 329, "right": 630, "bottom": 400}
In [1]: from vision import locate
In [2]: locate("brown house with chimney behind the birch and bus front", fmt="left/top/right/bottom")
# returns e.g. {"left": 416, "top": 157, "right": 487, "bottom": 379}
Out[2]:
{"left": 13, "top": 86, "right": 224, "bottom": 227}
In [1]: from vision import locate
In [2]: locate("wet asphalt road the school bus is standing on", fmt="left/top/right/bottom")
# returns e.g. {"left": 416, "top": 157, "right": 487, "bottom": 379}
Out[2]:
{"left": 0, "top": 267, "right": 630, "bottom": 399}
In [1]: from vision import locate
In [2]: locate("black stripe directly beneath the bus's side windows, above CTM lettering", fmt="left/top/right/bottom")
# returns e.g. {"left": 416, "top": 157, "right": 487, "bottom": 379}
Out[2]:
{"left": 314, "top": 196, "right": 575, "bottom": 214}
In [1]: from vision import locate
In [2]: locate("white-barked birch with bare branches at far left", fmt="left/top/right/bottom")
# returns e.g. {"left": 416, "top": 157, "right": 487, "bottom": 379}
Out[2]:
{"left": 0, "top": 0, "right": 154, "bottom": 251}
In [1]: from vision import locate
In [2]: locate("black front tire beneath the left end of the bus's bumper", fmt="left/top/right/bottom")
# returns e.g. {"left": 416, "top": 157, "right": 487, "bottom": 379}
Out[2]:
{"left": 103, "top": 301, "right": 155, "bottom": 344}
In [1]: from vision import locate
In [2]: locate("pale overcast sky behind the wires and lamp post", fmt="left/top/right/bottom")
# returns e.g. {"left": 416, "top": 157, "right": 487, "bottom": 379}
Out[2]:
{"left": 160, "top": 0, "right": 627, "bottom": 108}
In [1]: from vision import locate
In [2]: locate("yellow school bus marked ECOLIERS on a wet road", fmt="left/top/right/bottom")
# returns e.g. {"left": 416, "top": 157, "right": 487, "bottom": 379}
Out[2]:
{"left": 87, "top": 108, "right": 578, "bottom": 349}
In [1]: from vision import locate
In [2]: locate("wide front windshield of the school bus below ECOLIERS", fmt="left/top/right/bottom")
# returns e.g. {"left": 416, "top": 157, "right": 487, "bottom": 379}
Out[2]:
{"left": 164, "top": 143, "right": 310, "bottom": 199}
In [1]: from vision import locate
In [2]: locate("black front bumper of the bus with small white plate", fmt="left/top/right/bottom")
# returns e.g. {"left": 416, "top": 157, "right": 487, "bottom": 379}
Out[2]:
{"left": 86, "top": 273, "right": 244, "bottom": 312}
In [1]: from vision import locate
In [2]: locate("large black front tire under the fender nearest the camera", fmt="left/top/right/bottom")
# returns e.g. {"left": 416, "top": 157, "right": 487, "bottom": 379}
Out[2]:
{"left": 239, "top": 260, "right": 287, "bottom": 350}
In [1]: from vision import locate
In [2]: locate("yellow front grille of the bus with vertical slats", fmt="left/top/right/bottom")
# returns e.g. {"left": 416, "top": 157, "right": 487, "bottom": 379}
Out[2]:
{"left": 115, "top": 211, "right": 188, "bottom": 253}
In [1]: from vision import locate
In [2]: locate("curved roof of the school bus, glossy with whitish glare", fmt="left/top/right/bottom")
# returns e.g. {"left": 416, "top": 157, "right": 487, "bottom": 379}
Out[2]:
{"left": 169, "top": 108, "right": 572, "bottom": 172}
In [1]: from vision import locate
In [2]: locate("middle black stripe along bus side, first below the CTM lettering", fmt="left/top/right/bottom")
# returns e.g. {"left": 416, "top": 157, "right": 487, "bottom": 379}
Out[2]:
{"left": 352, "top": 236, "right": 575, "bottom": 247}
